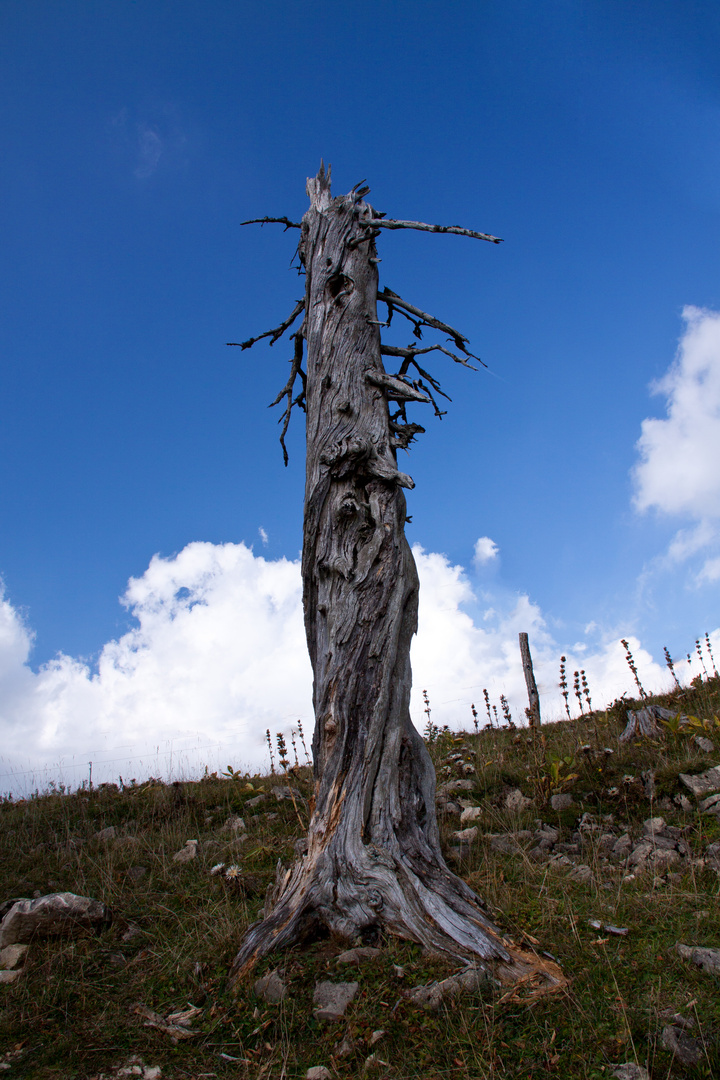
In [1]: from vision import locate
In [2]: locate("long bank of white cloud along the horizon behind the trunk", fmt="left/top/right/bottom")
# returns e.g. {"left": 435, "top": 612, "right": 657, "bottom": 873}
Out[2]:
{"left": 0, "top": 542, "right": 708, "bottom": 792}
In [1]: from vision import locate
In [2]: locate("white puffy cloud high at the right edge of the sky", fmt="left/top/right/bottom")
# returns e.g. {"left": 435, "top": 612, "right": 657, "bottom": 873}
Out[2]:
{"left": 633, "top": 307, "right": 720, "bottom": 581}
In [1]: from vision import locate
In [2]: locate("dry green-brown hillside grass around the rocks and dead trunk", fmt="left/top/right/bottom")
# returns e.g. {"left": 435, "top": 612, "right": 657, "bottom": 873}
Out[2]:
{"left": 0, "top": 677, "right": 720, "bottom": 1080}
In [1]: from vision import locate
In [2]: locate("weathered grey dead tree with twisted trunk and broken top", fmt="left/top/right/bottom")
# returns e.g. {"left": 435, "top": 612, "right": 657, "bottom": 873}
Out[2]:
{"left": 229, "top": 165, "right": 562, "bottom": 987}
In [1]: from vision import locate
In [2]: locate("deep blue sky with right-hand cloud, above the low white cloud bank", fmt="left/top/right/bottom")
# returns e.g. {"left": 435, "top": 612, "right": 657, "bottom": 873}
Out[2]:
{"left": 0, "top": 0, "right": 720, "bottom": 786}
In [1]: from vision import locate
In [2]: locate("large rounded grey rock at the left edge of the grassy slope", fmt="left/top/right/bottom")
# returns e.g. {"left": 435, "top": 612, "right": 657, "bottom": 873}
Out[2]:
{"left": 0, "top": 892, "right": 112, "bottom": 949}
